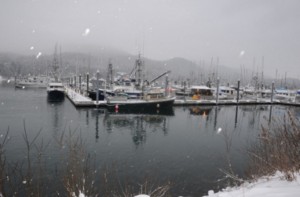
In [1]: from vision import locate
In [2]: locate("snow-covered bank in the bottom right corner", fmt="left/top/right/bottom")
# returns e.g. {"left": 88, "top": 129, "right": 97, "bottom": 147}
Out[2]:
{"left": 204, "top": 172, "right": 300, "bottom": 197}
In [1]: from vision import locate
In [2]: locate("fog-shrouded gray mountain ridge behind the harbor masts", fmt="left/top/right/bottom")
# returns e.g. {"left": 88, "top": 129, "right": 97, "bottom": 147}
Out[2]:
{"left": 0, "top": 46, "right": 300, "bottom": 87}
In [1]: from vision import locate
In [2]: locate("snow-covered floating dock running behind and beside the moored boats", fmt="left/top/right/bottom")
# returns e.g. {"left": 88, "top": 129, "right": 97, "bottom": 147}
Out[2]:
{"left": 66, "top": 87, "right": 300, "bottom": 107}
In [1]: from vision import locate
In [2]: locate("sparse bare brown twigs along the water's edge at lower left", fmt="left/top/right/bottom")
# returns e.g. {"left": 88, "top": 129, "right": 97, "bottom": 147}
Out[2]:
{"left": 0, "top": 121, "right": 170, "bottom": 197}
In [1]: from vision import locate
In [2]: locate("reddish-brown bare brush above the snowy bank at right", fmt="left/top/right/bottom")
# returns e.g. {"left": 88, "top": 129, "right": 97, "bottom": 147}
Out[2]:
{"left": 247, "top": 112, "right": 300, "bottom": 180}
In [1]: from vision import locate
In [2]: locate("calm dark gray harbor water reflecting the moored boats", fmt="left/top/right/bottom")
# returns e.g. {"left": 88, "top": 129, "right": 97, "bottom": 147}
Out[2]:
{"left": 0, "top": 81, "right": 299, "bottom": 196}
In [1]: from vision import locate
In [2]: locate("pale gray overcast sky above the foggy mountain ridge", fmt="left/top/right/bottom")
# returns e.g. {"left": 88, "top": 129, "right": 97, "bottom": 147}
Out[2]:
{"left": 0, "top": 0, "right": 300, "bottom": 78}
